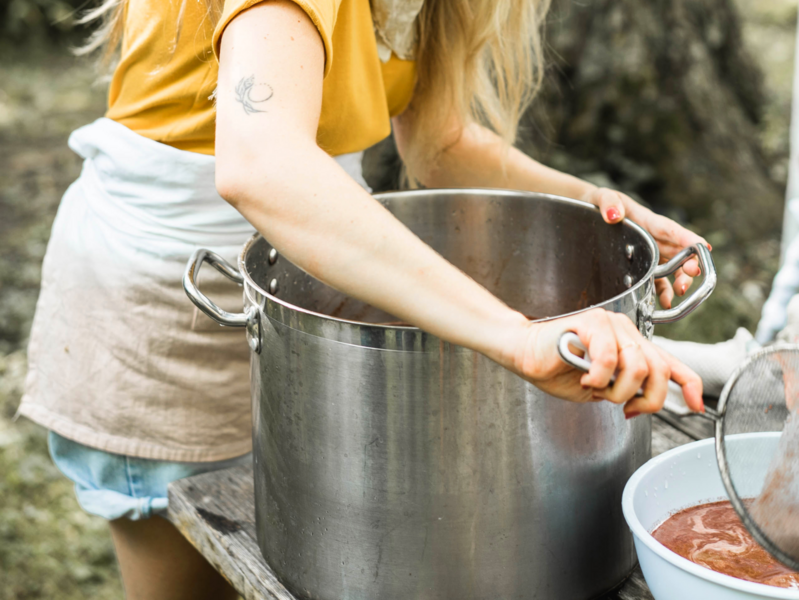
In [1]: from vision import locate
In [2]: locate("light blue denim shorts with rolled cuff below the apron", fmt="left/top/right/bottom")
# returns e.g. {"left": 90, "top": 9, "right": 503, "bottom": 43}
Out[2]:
{"left": 47, "top": 431, "right": 252, "bottom": 521}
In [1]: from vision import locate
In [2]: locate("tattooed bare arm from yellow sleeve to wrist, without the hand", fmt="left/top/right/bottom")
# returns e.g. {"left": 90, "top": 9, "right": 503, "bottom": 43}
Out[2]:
{"left": 216, "top": 2, "right": 525, "bottom": 359}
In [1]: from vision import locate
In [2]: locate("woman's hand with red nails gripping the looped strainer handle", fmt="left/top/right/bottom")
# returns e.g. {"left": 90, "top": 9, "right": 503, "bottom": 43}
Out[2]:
{"left": 500, "top": 308, "right": 704, "bottom": 418}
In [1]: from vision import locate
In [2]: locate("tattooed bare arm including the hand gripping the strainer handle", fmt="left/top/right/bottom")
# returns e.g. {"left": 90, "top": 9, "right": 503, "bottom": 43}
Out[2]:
{"left": 216, "top": 0, "right": 701, "bottom": 412}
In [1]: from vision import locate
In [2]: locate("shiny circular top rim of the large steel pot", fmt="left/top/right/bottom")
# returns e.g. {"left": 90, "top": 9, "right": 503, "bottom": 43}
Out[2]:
{"left": 237, "top": 188, "right": 660, "bottom": 331}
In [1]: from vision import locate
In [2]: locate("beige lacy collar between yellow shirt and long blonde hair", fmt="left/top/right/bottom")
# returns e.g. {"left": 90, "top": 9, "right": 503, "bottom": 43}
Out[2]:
{"left": 372, "top": 0, "right": 424, "bottom": 62}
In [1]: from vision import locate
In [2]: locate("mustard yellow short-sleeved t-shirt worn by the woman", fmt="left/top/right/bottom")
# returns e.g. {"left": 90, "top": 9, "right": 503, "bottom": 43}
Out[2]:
{"left": 106, "top": 0, "right": 416, "bottom": 156}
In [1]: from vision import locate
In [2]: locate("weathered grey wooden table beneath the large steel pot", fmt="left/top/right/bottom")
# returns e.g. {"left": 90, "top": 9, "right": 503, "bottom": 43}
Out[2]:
{"left": 169, "top": 415, "right": 713, "bottom": 600}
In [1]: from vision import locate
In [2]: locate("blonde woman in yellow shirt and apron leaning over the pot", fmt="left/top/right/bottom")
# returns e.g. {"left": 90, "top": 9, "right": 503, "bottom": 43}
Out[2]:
{"left": 20, "top": 0, "right": 702, "bottom": 600}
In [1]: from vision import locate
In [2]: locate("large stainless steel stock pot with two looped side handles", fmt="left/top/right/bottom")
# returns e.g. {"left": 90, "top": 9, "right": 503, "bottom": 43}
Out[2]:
{"left": 185, "top": 190, "right": 715, "bottom": 600}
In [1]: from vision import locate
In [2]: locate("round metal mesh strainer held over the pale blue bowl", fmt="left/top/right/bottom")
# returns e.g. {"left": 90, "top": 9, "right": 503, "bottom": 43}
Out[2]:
{"left": 559, "top": 332, "right": 799, "bottom": 571}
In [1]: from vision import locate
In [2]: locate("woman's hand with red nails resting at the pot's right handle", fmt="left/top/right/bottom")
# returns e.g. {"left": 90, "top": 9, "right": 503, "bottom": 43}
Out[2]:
{"left": 582, "top": 188, "right": 712, "bottom": 308}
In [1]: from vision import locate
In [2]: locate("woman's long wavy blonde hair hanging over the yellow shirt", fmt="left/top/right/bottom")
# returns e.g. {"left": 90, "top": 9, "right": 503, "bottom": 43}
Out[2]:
{"left": 77, "top": 0, "right": 550, "bottom": 182}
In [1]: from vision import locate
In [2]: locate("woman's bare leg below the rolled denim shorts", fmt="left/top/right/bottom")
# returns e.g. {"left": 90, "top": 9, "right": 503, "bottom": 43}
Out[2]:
{"left": 109, "top": 517, "right": 238, "bottom": 600}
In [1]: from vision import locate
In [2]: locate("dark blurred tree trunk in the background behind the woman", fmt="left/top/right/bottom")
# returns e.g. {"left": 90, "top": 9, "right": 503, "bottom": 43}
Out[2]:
{"left": 365, "top": 0, "right": 782, "bottom": 243}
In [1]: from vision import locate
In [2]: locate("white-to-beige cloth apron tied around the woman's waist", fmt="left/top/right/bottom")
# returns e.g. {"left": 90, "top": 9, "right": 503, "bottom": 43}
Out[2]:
{"left": 19, "top": 119, "right": 363, "bottom": 461}
